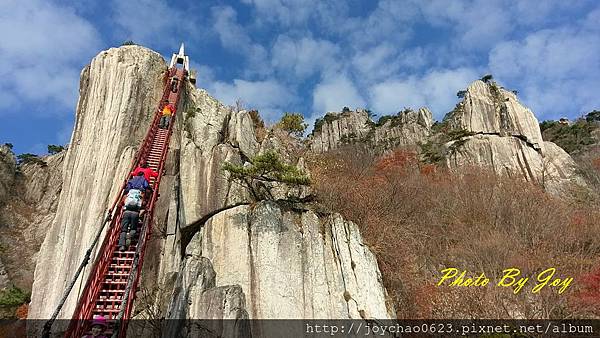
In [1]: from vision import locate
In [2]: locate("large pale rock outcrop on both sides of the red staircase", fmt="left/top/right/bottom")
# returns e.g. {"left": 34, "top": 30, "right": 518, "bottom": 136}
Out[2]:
{"left": 29, "top": 46, "right": 394, "bottom": 336}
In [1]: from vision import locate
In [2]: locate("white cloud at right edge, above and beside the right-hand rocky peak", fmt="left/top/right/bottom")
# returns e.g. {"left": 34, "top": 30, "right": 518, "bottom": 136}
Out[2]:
{"left": 489, "top": 27, "right": 600, "bottom": 118}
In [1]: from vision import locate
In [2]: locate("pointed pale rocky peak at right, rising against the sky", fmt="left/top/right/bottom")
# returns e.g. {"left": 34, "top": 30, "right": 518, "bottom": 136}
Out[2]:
{"left": 446, "top": 80, "right": 543, "bottom": 150}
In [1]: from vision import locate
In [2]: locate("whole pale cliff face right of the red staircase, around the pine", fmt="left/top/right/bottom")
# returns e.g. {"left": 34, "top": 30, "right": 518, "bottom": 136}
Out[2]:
{"left": 149, "top": 84, "right": 394, "bottom": 336}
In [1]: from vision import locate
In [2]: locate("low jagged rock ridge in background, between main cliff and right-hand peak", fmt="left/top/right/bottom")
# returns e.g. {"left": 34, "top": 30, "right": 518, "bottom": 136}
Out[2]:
{"left": 309, "top": 108, "right": 433, "bottom": 153}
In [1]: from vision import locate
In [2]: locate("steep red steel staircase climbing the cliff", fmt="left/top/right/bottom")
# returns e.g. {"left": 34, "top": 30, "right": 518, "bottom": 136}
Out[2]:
{"left": 65, "top": 44, "right": 189, "bottom": 338}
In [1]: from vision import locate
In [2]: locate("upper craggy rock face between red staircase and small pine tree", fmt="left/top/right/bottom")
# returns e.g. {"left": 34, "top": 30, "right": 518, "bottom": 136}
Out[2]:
{"left": 178, "top": 89, "right": 258, "bottom": 224}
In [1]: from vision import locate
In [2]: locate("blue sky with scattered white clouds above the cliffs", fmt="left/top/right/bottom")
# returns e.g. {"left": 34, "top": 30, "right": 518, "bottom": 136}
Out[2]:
{"left": 0, "top": 0, "right": 600, "bottom": 154}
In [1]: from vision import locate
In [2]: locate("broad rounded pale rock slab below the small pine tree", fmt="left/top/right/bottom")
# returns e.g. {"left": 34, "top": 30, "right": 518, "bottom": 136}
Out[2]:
{"left": 198, "top": 202, "right": 394, "bottom": 319}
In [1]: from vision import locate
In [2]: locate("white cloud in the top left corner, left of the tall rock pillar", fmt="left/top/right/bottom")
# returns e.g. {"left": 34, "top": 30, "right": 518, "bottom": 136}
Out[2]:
{"left": 0, "top": 0, "right": 100, "bottom": 113}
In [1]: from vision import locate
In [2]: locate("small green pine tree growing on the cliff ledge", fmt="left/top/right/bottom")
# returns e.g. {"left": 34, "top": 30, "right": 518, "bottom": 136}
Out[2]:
{"left": 222, "top": 151, "right": 310, "bottom": 201}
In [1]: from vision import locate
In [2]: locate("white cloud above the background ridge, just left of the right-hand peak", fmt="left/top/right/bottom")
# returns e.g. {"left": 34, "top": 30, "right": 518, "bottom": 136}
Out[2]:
{"left": 369, "top": 68, "right": 477, "bottom": 118}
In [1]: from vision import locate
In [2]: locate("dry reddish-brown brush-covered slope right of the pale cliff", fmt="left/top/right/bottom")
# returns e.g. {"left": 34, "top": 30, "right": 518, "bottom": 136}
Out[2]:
{"left": 309, "top": 148, "right": 600, "bottom": 318}
